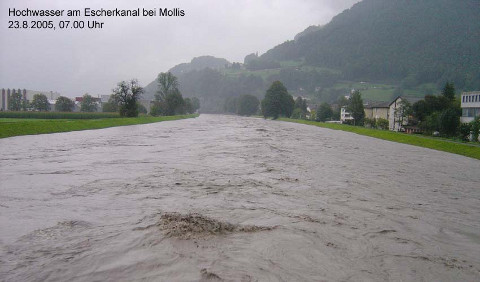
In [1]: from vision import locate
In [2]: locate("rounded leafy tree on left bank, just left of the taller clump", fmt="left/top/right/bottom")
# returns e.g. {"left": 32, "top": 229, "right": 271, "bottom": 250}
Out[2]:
{"left": 113, "top": 79, "right": 143, "bottom": 117}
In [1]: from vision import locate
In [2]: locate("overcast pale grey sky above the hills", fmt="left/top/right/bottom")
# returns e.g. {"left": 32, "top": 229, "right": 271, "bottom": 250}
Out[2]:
{"left": 0, "top": 0, "right": 359, "bottom": 97}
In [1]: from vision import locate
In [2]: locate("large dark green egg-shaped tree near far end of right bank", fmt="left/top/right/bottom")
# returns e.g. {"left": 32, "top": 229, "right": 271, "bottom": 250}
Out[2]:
{"left": 262, "top": 81, "right": 295, "bottom": 119}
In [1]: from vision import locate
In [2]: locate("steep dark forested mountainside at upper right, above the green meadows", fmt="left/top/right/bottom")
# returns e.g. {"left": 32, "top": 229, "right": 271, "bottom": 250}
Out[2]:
{"left": 261, "top": 0, "right": 480, "bottom": 89}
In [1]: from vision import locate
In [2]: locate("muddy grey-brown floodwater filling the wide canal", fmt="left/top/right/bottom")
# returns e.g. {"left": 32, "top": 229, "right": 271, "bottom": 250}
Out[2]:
{"left": 0, "top": 115, "right": 480, "bottom": 281}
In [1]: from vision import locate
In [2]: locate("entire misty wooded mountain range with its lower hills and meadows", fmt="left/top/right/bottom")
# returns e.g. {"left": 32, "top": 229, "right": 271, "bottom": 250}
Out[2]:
{"left": 145, "top": 0, "right": 480, "bottom": 112}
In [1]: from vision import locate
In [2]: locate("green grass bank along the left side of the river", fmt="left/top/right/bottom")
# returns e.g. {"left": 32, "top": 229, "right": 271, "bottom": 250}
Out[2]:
{"left": 0, "top": 115, "right": 198, "bottom": 138}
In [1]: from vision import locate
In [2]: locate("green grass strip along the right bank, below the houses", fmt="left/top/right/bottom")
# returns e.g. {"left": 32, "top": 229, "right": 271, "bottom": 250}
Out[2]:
{"left": 279, "top": 118, "right": 480, "bottom": 160}
